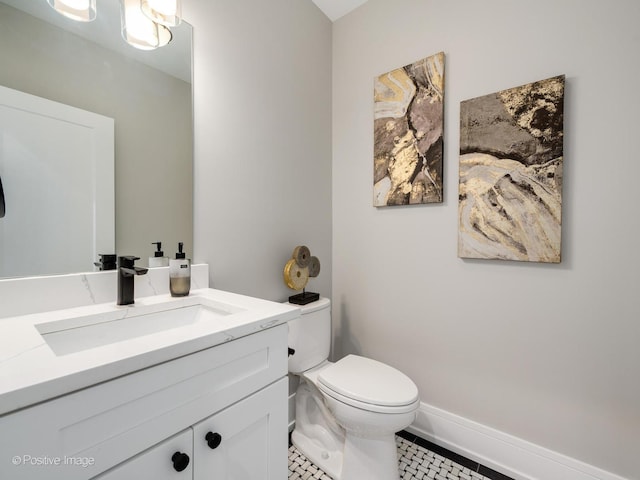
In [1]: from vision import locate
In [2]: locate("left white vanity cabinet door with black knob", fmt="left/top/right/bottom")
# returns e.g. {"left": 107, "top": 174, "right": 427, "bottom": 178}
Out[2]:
{"left": 94, "top": 428, "right": 193, "bottom": 480}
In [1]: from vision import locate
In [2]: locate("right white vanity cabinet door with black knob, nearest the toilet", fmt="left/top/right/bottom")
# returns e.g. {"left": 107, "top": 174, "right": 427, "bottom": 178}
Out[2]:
{"left": 193, "top": 378, "right": 288, "bottom": 480}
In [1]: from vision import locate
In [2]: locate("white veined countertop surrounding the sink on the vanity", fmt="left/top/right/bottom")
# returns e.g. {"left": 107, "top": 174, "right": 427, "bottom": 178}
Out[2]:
{"left": 0, "top": 288, "right": 300, "bottom": 415}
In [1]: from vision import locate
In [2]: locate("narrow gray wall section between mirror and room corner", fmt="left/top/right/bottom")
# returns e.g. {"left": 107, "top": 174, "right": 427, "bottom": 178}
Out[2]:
{"left": 183, "top": 0, "right": 331, "bottom": 301}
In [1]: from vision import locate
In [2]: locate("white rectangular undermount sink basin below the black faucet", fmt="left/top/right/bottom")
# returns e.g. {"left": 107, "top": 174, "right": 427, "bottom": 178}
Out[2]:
{"left": 34, "top": 303, "right": 243, "bottom": 356}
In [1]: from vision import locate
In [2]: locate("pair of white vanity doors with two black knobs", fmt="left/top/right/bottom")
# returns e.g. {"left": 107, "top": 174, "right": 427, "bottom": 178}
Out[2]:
{"left": 95, "top": 379, "right": 288, "bottom": 480}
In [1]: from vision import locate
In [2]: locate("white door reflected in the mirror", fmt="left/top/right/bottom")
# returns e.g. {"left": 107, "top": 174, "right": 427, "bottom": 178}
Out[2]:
{"left": 0, "top": 86, "right": 115, "bottom": 277}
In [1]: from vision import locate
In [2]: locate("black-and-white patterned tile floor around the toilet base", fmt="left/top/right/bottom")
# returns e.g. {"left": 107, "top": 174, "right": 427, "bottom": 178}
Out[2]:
{"left": 289, "top": 432, "right": 511, "bottom": 480}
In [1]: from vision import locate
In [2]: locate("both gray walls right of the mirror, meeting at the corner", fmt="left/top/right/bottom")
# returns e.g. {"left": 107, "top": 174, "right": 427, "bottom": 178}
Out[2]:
{"left": 184, "top": 0, "right": 640, "bottom": 478}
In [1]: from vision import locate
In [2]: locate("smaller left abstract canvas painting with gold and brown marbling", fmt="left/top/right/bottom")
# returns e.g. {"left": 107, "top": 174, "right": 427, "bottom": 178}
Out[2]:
{"left": 373, "top": 52, "right": 444, "bottom": 207}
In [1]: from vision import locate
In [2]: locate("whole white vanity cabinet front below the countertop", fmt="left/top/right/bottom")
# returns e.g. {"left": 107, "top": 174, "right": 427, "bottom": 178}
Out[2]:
{"left": 0, "top": 324, "right": 287, "bottom": 480}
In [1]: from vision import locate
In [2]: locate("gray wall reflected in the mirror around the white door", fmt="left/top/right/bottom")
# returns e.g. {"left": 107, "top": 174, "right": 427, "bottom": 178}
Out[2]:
{"left": 0, "top": 4, "right": 193, "bottom": 271}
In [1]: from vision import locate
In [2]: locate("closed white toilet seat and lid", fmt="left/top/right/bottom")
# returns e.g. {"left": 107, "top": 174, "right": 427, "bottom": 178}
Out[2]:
{"left": 317, "top": 355, "right": 420, "bottom": 413}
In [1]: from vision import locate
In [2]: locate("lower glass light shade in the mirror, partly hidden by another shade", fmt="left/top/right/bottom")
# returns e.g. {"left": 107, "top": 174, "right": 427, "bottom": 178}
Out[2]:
{"left": 120, "top": 0, "right": 172, "bottom": 50}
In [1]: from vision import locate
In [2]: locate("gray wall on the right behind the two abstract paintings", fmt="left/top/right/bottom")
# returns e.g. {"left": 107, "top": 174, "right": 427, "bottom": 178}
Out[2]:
{"left": 332, "top": 0, "right": 640, "bottom": 478}
